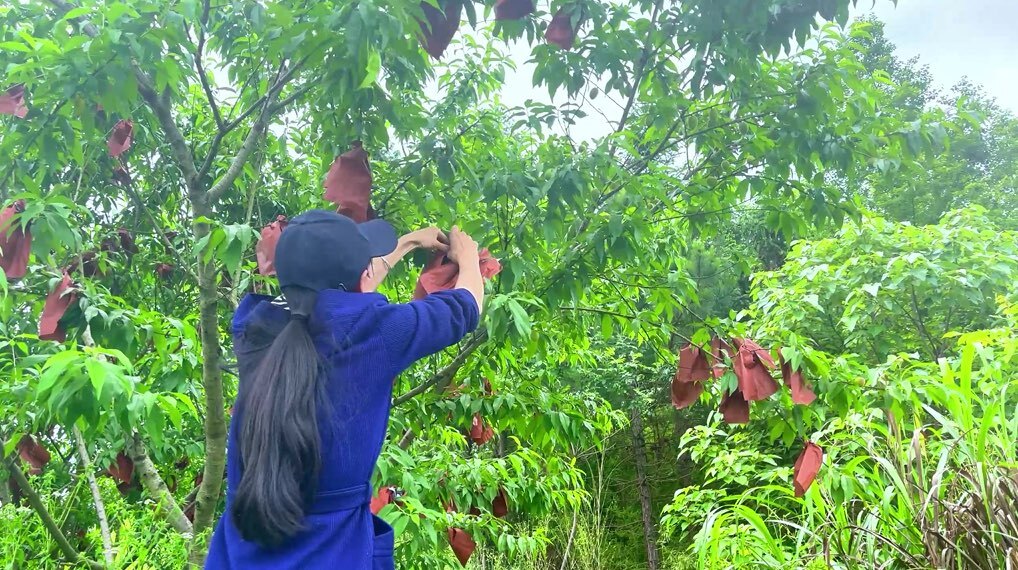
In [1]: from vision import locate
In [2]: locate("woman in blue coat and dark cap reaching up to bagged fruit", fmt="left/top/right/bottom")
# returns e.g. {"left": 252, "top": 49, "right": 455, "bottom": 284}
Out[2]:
{"left": 206, "top": 211, "right": 484, "bottom": 570}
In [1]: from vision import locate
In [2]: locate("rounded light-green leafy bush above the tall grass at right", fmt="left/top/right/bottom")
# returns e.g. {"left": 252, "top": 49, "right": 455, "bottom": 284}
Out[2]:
{"left": 748, "top": 208, "right": 1018, "bottom": 363}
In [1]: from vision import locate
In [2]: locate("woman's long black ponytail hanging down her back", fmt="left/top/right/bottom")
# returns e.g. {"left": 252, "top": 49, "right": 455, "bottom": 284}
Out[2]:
{"left": 231, "top": 288, "right": 324, "bottom": 548}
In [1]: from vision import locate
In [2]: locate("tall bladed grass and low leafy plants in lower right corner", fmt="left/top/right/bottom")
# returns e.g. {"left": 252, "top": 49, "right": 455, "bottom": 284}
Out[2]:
{"left": 663, "top": 323, "right": 1018, "bottom": 568}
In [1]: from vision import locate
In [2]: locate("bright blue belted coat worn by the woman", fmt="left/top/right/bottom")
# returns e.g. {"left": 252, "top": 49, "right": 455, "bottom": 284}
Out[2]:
{"left": 205, "top": 289, "right": 478, "bottom": 570}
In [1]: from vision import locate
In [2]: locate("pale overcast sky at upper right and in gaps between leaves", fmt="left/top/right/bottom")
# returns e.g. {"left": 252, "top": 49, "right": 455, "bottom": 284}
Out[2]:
{"left": 488, "top": 0, "right": 1018, "bottom": 140}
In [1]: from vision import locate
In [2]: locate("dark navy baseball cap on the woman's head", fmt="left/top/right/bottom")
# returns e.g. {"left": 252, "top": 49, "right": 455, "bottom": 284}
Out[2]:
{"left": 276, "top": 210, "right": 397, "bottom": 291}
